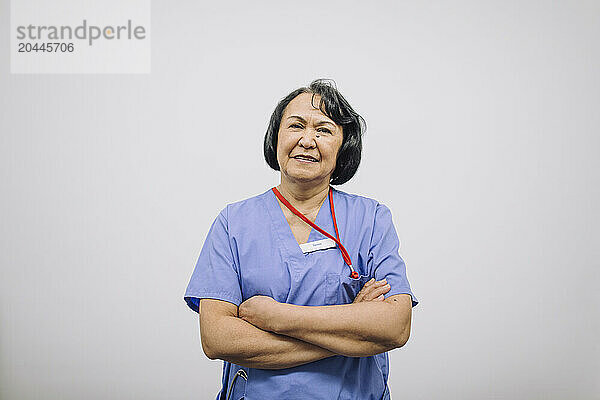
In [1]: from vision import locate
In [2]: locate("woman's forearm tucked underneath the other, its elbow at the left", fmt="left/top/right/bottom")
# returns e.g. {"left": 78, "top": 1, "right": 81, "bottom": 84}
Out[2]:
{"left": 201, "top": 316, "right": 336, "bottom": 369}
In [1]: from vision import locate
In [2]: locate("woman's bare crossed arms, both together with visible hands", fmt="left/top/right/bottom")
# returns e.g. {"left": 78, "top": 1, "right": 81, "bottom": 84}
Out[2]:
{"left": 200, "top": 282, "right": 412, "bottom": 369}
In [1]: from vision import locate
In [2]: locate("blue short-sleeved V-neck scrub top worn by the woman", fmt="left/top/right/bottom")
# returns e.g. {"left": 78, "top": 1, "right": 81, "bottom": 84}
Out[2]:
{"left": 184, "top": 188, "right": 418, "bottom": 400}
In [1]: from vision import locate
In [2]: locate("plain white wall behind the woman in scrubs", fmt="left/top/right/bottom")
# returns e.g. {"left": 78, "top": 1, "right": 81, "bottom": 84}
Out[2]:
{"left": 0, "top": 0, "right": 600, "bottom": 400}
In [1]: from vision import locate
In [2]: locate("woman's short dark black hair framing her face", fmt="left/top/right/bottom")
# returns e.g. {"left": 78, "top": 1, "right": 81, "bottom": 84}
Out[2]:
{"left": 264, "top": 79, "right": 367, "bottom": 185}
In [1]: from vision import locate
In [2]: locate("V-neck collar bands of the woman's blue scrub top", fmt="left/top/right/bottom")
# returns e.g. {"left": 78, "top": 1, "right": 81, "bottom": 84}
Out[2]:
{"left": 265, "top": 188, "right": 335, "bottom": 259}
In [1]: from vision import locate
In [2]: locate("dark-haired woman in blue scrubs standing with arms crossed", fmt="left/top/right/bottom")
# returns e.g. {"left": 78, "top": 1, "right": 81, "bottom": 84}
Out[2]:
{"left": 184, "top": 80, "right": 418, "bottom": 400}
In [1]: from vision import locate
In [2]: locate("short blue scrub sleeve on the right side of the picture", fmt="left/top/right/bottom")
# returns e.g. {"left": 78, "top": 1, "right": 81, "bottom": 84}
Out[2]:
{"left": 369, "top": 204, "right": 419, "bottom": 307}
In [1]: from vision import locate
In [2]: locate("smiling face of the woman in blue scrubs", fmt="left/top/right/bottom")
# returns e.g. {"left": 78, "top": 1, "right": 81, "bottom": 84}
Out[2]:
{"left": 277, "top": 93, "right": 343, "bottom": 184}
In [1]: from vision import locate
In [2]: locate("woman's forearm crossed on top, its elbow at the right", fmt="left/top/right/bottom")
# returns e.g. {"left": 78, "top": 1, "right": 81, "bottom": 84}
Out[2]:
{"left": 273, "top": 301, "right": 407, "bottom": 357}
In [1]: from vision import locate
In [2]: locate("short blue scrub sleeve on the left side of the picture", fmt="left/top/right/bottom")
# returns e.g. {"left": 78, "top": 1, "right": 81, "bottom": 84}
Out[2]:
{"left": 183, "top": 208, "right": 242, "bottom": 312}
